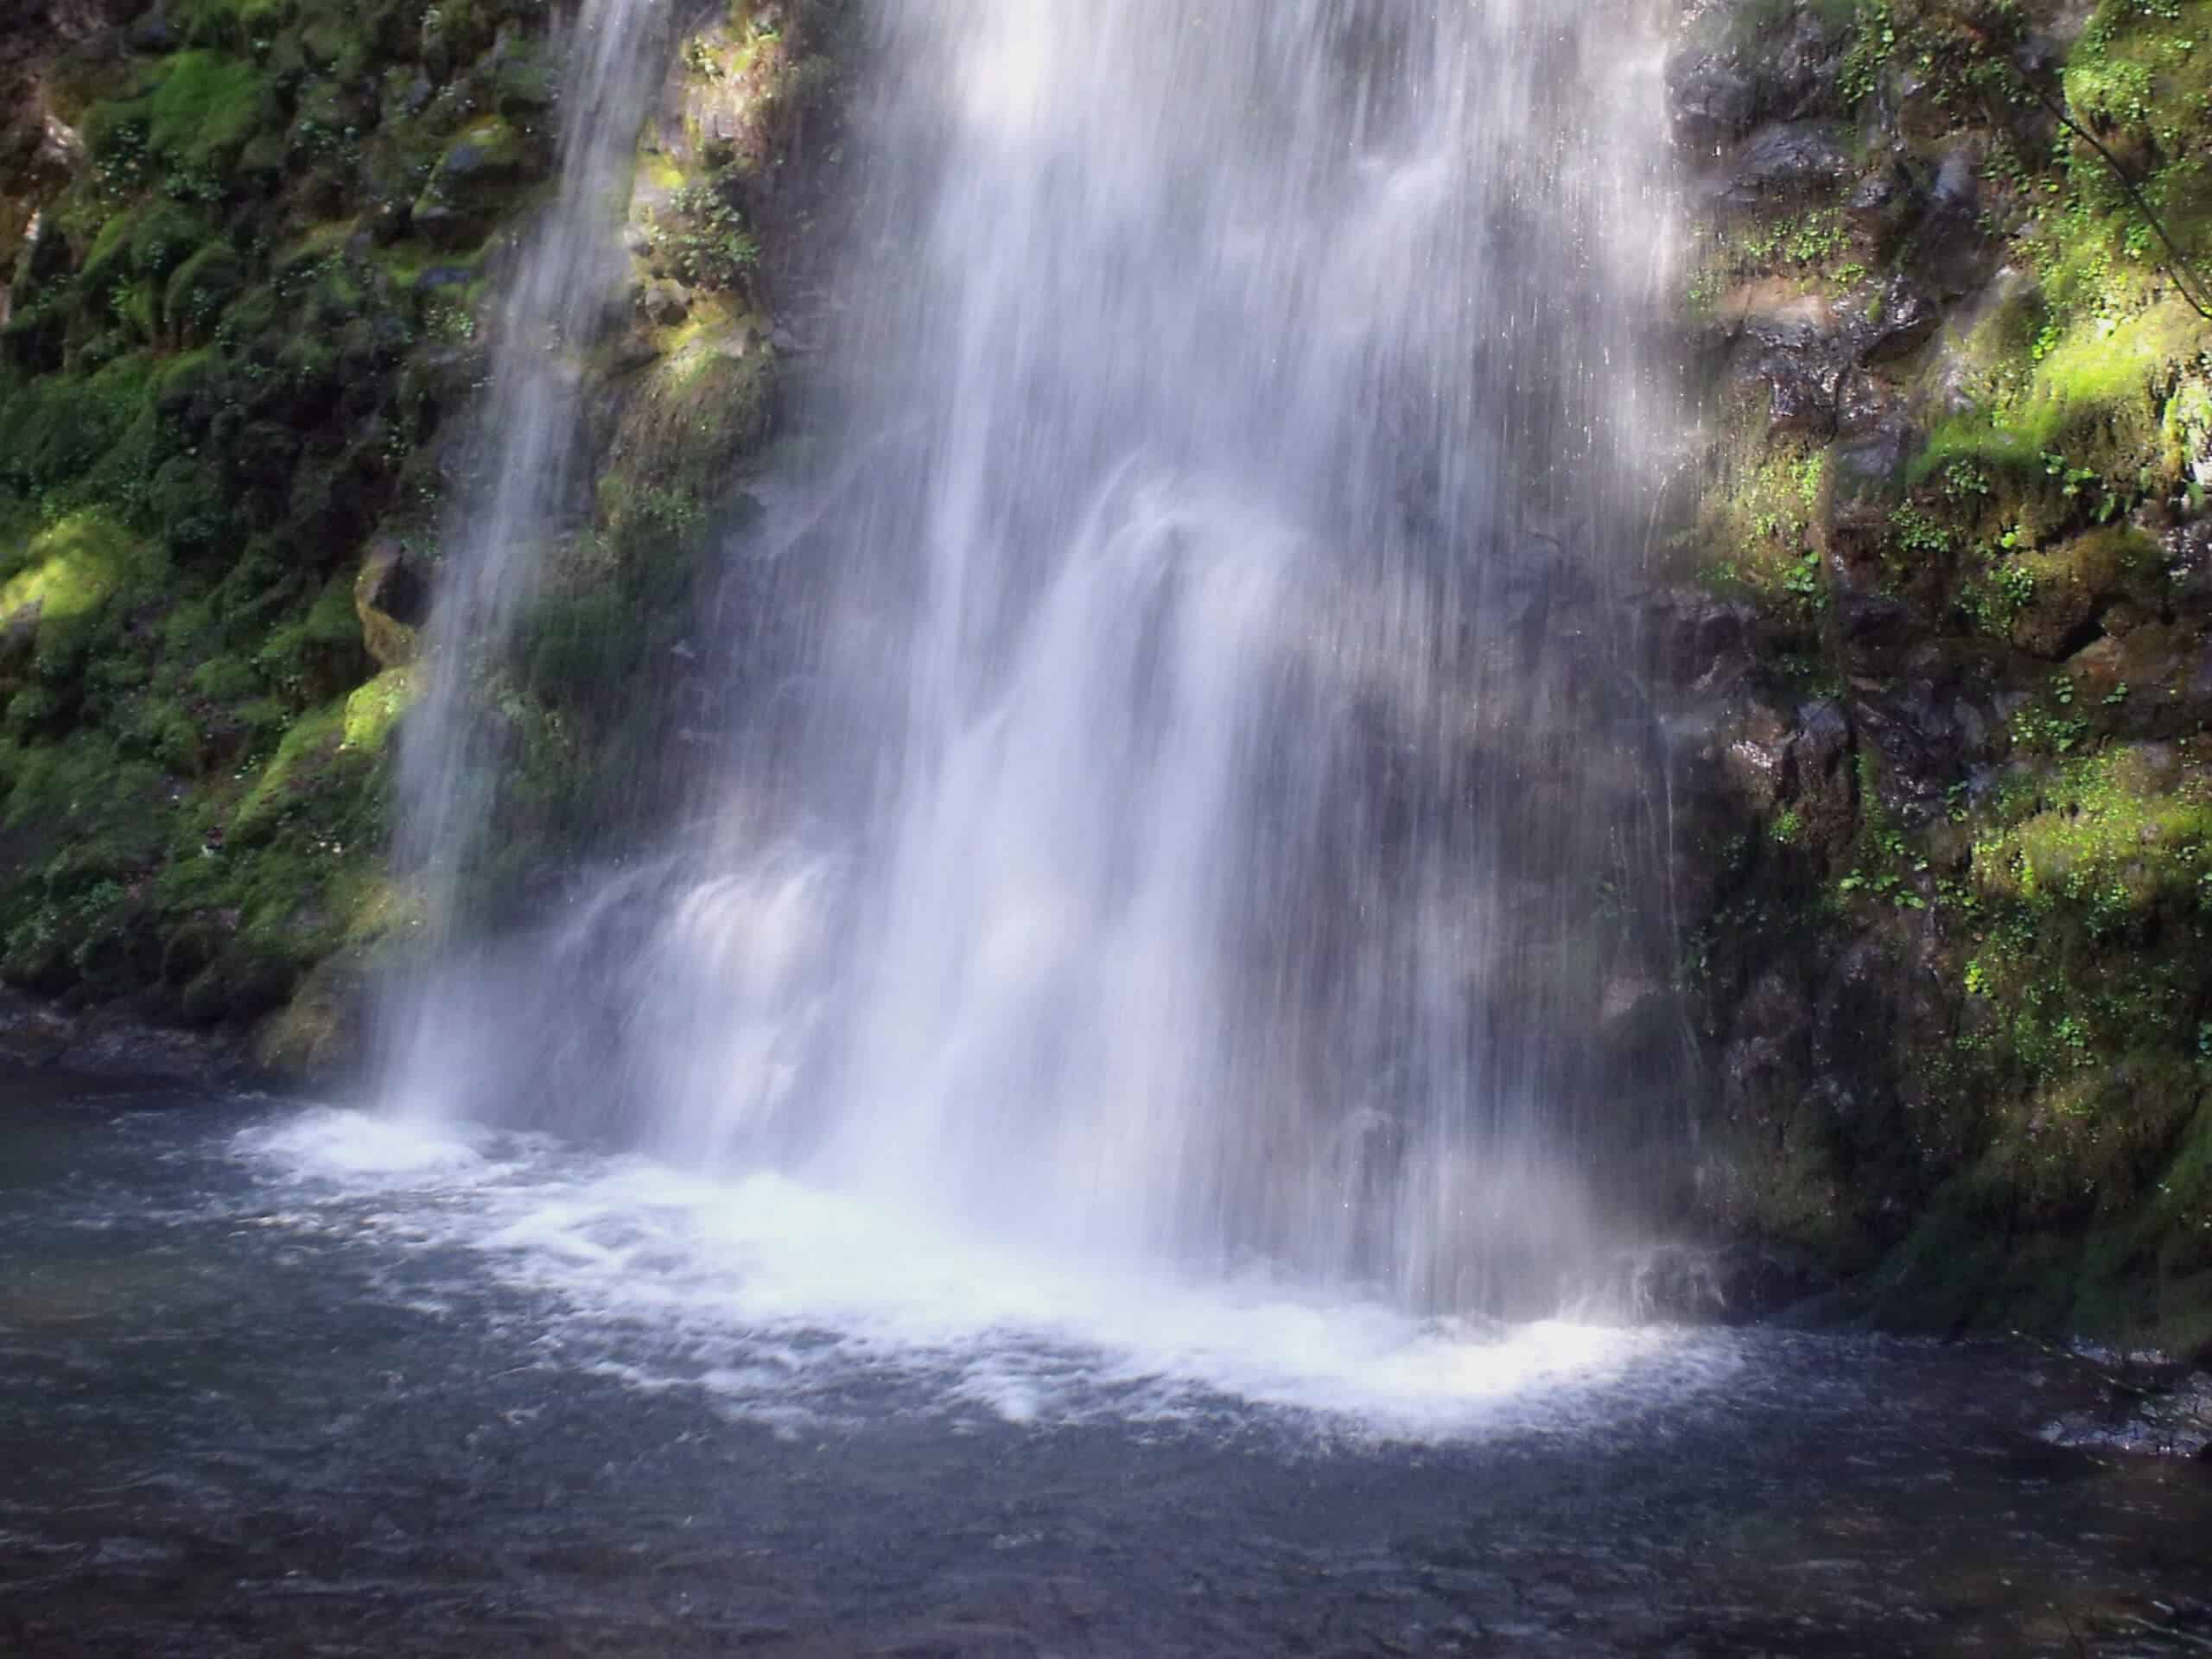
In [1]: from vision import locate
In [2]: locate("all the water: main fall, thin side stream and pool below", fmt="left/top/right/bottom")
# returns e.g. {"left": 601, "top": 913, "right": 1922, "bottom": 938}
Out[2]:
{"left": 0, "top": 0, "right": 2212, "bottom": 1659}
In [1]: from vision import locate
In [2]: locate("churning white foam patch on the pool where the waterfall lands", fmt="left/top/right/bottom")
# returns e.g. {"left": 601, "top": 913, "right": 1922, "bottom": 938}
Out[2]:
{"left": 237, "top": 1110, "right": 1734, "bottom": 1438}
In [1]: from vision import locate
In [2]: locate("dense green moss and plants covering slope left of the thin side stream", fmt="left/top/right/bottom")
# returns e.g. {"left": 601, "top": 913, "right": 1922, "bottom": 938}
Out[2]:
{"left": 0, "top": 0, "right": 579, "bottom": 1020}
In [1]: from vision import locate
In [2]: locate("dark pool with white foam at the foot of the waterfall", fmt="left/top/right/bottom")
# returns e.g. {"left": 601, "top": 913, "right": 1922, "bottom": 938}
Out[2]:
{"left": 0, "top": 1082, "right": 2212, "bottom": 1659}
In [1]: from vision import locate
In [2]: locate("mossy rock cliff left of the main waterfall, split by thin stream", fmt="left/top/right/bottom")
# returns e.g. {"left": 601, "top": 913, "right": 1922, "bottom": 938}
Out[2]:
{"left": 0, "top": 0, "right": 841, "bottom": 1079}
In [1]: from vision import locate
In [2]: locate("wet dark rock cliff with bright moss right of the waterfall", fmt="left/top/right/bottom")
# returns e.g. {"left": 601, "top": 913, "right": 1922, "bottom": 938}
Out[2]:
{"left": 1652, "top": 0, "right": 2212, "bottom": 1350}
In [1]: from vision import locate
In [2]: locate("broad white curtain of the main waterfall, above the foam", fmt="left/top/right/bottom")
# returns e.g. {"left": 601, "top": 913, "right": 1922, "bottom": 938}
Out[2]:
{"left": 393, "top": 0, "right": 1672, "bottom": 1310}
